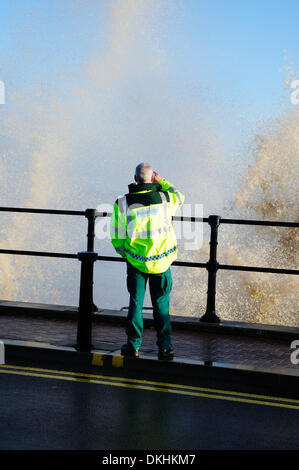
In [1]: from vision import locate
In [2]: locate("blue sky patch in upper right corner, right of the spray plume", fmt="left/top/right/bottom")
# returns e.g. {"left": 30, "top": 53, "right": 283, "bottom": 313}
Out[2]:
{"left": 165, "top": 0, "right": 299, "bottom": 121}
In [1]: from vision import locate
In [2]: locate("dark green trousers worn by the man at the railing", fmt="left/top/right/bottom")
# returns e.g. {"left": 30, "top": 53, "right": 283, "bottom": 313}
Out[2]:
{"left": 126, "top": 262, "right": 172, "bottom": 349}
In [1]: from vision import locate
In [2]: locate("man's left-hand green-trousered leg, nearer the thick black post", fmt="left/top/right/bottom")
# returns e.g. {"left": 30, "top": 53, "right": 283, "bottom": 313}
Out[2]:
{"left": 126, "top": 263, "right": 147, "bottom": 350}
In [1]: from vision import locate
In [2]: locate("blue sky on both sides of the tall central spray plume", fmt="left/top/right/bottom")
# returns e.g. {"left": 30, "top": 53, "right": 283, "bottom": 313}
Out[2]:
{"left": 0, "top": 0, "right": 299, "bottom": 158}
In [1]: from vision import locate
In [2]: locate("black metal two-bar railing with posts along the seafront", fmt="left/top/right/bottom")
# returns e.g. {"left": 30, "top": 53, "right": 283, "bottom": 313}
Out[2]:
{"left": 0, "top": 207, "right": 299, "bottom": 351}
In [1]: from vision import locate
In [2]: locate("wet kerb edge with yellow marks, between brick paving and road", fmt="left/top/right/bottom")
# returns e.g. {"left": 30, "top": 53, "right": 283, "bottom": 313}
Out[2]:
{"left": 2, "top": 339, "right": 299, "bottom": 393}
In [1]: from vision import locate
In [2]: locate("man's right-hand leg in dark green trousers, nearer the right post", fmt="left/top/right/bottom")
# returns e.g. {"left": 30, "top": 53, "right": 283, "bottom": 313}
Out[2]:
{"left": 149, "top": 268, "right": 172, "bottom": 351}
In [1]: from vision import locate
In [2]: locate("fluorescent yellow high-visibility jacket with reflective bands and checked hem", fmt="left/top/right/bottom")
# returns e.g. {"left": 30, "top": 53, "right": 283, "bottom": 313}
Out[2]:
{"left": 110, "top": 178, "right": 184, "bottom": 273}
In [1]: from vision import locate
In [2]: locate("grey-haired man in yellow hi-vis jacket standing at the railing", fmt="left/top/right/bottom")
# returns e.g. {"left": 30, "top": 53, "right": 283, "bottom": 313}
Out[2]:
{"left": 110, "top": 163, "right": 184, "bottom": 360}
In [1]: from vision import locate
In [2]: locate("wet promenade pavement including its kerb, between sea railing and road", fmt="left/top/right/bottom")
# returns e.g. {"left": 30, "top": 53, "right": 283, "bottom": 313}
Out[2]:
{"left": 0, "top": 301, "right": 299, "bottom": 392}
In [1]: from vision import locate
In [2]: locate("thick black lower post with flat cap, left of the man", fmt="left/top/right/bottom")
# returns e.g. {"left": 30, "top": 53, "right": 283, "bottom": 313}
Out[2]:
{"left": 76, "top": 251, "right": 97, "bottom": 351}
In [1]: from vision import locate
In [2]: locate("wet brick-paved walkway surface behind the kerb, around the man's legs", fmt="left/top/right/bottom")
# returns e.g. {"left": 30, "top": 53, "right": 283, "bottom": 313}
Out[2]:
{"left": 0, "top": 313, "right": 299, "bottom": 370}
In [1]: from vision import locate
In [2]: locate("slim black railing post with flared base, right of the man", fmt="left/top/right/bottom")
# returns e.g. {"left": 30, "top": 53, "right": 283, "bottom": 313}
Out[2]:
{"left": 200, "top": 215, "right": 220, "bottom": 323}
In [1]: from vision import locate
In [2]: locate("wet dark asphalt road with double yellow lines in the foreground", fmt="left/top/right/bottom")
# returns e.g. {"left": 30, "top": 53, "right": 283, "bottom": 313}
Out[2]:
{"left": 0, "top": 365, "right": 299, "bottom": 450}
